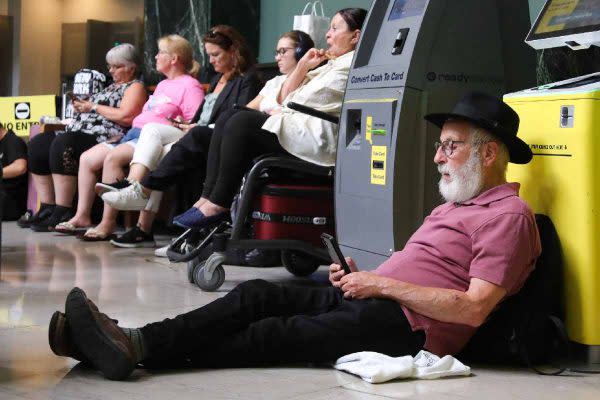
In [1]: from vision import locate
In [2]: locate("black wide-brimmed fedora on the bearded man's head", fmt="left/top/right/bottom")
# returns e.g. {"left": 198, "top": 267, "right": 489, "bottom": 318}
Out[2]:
{"left": 425, "top": 92, "right": 533, "bottom": 164}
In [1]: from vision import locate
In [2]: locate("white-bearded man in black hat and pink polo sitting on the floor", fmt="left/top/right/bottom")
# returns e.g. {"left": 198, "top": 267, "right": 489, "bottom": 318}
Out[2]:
{"left": 50, "top": 93, "right": 540, "bottom": 379}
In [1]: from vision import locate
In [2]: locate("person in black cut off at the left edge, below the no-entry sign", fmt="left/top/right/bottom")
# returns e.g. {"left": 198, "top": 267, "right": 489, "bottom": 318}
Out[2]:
{"left": 0, "top": 123, "right": 27, "bottom": 221}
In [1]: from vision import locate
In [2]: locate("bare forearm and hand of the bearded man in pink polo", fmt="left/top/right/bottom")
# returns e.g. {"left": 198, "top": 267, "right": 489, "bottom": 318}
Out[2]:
{"left": 340, "top": 272, "right": 506, "bottom": 327}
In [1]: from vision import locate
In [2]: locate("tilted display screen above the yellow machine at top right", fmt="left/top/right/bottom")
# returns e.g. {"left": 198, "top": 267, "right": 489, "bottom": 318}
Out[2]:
{"left": 527, "top": 0, "right": 600, "bottom": 40}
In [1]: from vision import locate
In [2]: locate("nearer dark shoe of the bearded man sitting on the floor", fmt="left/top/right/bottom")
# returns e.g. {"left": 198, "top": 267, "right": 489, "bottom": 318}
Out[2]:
{"left": 65, "top": 288, "right": 135, "bottom": 380}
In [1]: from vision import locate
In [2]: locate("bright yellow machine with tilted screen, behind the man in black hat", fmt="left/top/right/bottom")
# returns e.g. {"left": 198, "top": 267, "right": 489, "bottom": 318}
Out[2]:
{"left": 504, "top": 0, "right": 600, "bottom": 369}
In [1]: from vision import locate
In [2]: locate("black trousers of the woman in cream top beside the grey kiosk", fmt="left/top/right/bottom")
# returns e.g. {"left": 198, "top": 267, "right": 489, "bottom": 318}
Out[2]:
{"left": 202, "top": 111, "right": 289, "bottom": 208}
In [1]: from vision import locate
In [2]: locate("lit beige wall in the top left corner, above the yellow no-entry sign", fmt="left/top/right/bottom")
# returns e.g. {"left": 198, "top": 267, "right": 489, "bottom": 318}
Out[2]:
{"left": 15, "top": 0, "right": 144, "bottom": 95}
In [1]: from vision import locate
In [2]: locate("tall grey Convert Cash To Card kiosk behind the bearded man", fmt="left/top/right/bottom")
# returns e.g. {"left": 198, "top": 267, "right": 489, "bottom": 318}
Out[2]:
{"left": 335, "top": 0, "right": 536, "bottom": 270}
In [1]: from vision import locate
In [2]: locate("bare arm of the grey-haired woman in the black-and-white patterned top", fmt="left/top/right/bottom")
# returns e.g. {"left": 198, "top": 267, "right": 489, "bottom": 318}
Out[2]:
{"left": 73, "top": 82, "right": 146, "bottom": 126}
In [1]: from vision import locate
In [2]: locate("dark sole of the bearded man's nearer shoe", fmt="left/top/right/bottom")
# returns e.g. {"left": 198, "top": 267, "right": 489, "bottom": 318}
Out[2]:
{"left": 65, "top": 288, "right": 135, "bottom": 380}
